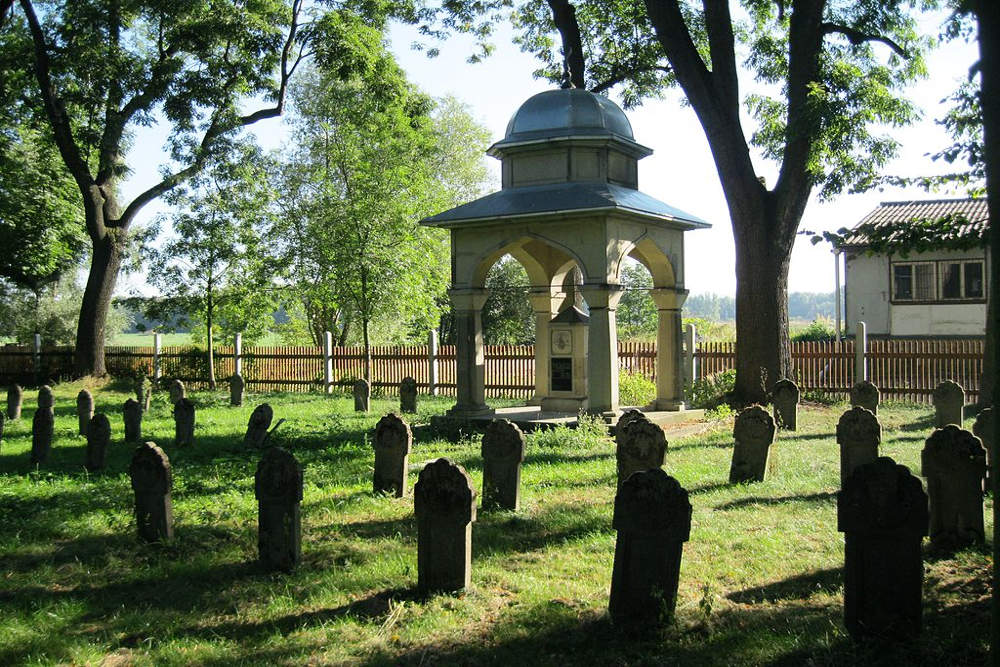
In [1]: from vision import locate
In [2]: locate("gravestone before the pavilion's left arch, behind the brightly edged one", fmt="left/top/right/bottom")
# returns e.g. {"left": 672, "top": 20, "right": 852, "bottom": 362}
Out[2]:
{"left": 480, "top": 419, "right": 524, "bottom": 512}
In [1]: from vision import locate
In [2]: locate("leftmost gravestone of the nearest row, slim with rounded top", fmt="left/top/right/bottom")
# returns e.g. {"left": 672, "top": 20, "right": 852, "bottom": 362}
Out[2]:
{"left": 128, "top": 442, "right": 174, "bottom": 542}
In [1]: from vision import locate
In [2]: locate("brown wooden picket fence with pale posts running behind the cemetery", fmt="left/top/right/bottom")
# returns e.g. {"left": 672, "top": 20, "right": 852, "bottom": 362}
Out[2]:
{"left": 0, "top": 338, "right": 985, "bottom": 402}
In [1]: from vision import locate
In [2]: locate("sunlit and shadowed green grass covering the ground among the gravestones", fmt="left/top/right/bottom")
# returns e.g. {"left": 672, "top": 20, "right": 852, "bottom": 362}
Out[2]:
{"left": 0, "top": 384, "right": 990, "bottom": 665}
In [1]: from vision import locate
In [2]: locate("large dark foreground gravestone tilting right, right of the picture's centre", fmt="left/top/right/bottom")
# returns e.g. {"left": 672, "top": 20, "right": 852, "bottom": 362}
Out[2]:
{"left": 608, "top": 468, "right": 691, "bottom": 630}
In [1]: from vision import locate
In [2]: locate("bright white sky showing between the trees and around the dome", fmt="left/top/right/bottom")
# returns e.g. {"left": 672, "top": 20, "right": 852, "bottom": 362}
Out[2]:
{"left": 118, "top": 9, "right": 976, "bottom": 295}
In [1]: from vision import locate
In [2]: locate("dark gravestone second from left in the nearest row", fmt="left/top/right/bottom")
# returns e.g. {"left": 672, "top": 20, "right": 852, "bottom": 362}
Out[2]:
{"left": 254, "top": 447, "right": 302, "bottom": 572}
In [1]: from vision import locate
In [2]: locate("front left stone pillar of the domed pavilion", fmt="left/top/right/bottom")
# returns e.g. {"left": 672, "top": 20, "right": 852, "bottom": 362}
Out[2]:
{"left": 448, "top": 288, "right": 493, "bottom": 419}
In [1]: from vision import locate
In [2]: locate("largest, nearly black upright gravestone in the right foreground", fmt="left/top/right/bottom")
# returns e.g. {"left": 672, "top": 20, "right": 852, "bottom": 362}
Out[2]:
{"left": 837, "top": 456, "right": 928, "bottom": 640}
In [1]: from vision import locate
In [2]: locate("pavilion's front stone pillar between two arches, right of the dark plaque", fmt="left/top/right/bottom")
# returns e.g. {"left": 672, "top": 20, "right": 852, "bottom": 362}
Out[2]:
{"left": 581, "top": 284, "right": 624, "bottom": 418}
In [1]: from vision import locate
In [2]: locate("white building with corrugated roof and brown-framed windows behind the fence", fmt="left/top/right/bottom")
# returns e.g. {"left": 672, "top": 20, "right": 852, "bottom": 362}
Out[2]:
{"left": 841, "top": 199, "right": 990, "bottom": 336}
